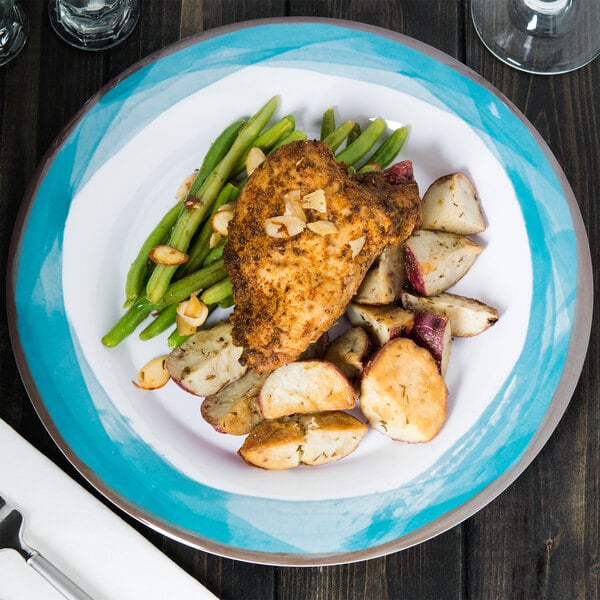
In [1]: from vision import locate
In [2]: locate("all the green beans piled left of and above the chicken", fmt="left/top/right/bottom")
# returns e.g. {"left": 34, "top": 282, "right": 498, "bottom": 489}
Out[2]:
{"left": 102, "top": 96, "right": 408, "bottom": 347}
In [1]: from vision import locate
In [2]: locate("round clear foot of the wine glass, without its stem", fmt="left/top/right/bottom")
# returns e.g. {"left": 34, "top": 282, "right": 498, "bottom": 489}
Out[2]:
{"left": 471, "top": 0, "right": 600, "bottom": 75}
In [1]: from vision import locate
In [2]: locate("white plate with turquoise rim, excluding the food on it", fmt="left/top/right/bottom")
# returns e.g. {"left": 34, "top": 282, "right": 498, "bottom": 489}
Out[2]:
{"left": 9, "top": 20, "right": 592, "bottom": 565}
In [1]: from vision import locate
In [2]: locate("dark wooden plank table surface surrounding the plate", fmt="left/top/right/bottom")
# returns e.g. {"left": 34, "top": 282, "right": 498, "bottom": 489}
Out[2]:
{"left": 0, "top": 0, "right": 600, "bottom": 600}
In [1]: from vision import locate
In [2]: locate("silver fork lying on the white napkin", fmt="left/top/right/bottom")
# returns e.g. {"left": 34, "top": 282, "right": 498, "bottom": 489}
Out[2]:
{"left": 0, "top": 496, "right": 92, "bottom": 600}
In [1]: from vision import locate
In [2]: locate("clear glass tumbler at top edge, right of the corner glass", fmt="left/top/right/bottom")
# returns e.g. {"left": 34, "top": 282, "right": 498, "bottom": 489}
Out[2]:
{"left": 48, "top": 0, "right": 140, "bottom": 50}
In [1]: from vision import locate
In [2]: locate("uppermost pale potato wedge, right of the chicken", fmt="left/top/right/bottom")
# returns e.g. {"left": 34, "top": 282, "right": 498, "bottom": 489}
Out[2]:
{"left": 420, "top": 173, "right": 486, "bottom": 235}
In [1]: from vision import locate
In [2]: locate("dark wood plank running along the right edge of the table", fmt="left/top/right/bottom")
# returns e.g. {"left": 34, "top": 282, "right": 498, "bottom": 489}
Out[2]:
{"left": 466, "top": 7, "right": 600, "bottom": 599}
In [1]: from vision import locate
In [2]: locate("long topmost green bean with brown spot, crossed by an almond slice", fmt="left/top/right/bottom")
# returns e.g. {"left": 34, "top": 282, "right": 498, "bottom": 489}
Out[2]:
{"left": 146, "top": 96, "right": 279, "bottom": 302}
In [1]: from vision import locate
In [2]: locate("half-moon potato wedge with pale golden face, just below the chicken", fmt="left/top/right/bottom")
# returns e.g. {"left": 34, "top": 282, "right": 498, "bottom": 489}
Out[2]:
{"left": 258, "top": 360, "right": 356, "bottom": 419}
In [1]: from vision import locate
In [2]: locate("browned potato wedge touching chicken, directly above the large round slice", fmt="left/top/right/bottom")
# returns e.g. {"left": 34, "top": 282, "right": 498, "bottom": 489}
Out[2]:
{"left": 346, "top": 302, "right": 413, "bottom": 346}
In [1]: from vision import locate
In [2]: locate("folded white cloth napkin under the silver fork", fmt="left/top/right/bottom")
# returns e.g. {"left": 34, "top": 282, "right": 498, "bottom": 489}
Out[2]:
{"left": 0, "top": 419, "right": 216, "bottom": 600}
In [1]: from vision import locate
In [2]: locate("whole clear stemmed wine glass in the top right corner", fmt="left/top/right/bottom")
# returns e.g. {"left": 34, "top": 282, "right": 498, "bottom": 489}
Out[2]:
{"left": 471, "top": 0, "right": 600, "bottom": 75}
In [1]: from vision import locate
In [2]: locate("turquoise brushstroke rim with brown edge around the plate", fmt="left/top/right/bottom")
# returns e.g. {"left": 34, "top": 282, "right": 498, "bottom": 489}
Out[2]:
{"left": 7, "top": 18, "right": 593, "bottom": 565}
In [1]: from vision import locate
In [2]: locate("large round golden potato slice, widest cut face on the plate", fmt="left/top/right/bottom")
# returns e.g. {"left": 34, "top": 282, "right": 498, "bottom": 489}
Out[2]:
{"left": 360, "top": 337, "right": 448, "bottom": 442}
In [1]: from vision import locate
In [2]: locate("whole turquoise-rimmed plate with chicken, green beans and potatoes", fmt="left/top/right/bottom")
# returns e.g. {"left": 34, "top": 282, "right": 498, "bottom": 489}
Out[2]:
{"left": 9, "top": 19, "right": 592, "bottom": 565}
